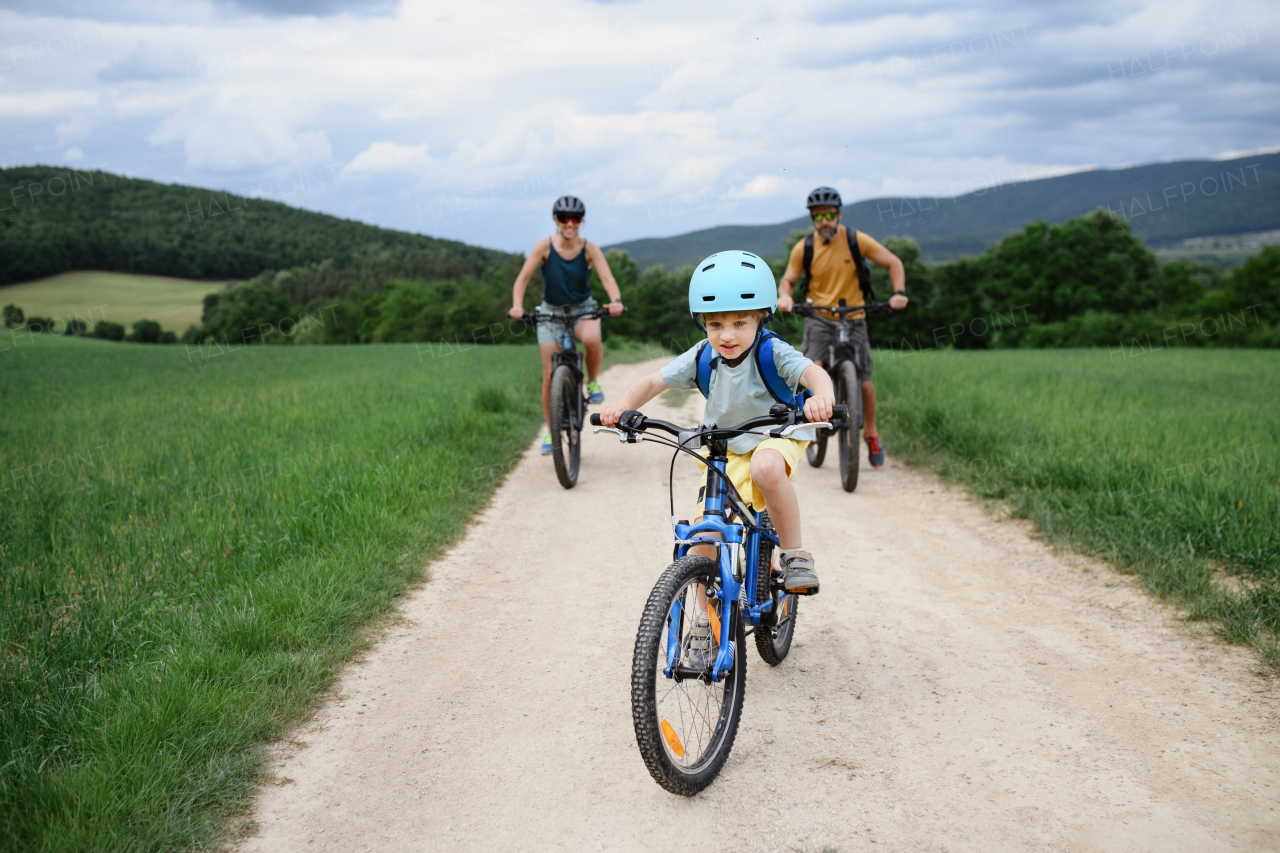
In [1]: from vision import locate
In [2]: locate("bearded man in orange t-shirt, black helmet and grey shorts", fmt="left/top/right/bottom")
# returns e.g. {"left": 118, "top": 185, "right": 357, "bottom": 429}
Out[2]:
{"left": 778, "top": 187, "right": 906, "bottom": 467}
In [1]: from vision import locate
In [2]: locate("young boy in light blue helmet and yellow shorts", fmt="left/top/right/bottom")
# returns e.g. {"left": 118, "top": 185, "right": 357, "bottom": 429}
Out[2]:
{"left": 600, "top": 245, "right": 835, "bottom": 591}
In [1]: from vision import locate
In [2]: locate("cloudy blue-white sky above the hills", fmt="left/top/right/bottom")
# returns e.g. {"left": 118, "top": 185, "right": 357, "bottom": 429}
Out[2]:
{"left": 0, "top": 0, "right": 1280, "bottom": 251}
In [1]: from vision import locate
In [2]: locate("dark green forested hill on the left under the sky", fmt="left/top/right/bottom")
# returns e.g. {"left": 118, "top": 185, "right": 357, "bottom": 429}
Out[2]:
{"left": 0, "top": 165, "right": 508, "bottom": 286}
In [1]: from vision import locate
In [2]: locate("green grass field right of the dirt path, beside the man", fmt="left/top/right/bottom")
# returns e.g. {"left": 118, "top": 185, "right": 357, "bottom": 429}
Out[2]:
{"left": 876, "top": 348, "right": 1280, "bottom": 666}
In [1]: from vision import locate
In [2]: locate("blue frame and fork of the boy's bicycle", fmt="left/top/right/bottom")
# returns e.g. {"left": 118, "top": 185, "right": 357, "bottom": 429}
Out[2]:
{"left": 663, "top": 441, "right": 781, "bottom": 681}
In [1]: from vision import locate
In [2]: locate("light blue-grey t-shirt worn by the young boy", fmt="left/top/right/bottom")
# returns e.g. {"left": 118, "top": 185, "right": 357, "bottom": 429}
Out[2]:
{"left": 662, "top": 339, "right": 814, "bottom": 453}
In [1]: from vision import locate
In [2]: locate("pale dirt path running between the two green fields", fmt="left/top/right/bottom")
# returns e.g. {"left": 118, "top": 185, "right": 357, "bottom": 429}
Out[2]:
{"left": 241, "top": 364, "right": 1280, "bottom": 853}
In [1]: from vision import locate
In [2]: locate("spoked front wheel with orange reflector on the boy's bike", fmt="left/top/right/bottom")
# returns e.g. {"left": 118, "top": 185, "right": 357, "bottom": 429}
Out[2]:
{"left": 631, "top": 556, "right": 746, "bottom": 797}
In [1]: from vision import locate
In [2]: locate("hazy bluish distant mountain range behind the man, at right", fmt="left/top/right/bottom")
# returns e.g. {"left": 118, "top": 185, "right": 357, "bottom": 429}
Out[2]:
{"left": 609, "top": 154, "right": 1280, "bottom": 269}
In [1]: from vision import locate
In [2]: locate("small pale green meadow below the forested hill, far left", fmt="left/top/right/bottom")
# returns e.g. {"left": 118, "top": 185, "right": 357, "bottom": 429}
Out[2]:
{"left": 0, "top": 272, "right": 223, "bottom": 336}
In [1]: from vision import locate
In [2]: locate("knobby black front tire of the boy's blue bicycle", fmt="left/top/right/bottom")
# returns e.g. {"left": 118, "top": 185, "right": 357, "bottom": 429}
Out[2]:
{"left": 631, "top": 556, "right": 746, "bottom": 797}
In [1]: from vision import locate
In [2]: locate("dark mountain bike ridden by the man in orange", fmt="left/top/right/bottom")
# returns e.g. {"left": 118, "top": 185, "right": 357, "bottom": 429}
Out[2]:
{"left": 792, "top": 300, "right": 893, "bottom": 492}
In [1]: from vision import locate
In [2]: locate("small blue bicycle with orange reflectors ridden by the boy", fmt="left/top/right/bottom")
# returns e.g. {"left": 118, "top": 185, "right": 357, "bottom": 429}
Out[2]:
{"left": 591, "top": 405, "right": 844, "bottom": 797}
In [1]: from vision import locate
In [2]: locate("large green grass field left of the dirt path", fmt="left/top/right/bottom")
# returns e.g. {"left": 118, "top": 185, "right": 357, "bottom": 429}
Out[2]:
{"left": 0, "top": 336, "right": 545, "bottom": 852}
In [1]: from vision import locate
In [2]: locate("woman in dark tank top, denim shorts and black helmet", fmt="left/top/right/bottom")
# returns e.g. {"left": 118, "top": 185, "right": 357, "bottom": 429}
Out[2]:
{"left": 508, "top": 196, "right": 622, "bottom": 456}
